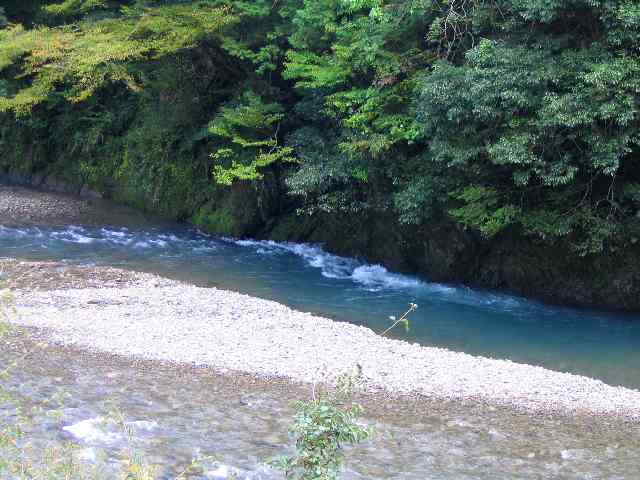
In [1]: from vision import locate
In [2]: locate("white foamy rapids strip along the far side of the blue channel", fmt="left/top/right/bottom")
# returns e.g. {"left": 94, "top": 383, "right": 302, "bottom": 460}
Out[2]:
{"left": 0, "top": 225, "right": 624, "bottom": 314}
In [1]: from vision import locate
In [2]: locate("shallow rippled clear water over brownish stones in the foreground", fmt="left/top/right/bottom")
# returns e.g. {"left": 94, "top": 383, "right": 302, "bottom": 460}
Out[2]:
{"left": 5, "top": 334, "right": 640, "bottom": 480}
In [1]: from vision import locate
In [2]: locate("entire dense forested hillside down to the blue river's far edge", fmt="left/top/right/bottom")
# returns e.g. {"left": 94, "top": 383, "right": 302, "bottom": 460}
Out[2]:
{"left": 0, "top": 0, "right": 640, "bottom": 309}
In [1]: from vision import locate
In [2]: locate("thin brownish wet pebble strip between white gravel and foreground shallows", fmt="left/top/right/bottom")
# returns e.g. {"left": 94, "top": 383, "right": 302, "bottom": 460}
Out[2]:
{"left": 11, "top": 325, "right": 640, "bottom": 431}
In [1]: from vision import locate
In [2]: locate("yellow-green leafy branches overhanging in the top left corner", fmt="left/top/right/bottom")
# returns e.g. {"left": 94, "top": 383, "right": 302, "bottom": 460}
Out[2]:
{"left": 0, "top": 3, "right": 234, "bottom": 115}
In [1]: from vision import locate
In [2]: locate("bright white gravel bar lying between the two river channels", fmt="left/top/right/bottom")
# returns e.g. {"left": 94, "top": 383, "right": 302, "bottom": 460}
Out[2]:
{"left": 8, "top": 267, "right": 640, "bottom": 421}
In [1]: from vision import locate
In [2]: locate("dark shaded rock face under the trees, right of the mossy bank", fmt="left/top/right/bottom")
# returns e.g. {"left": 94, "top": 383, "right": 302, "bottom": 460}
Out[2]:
{"left": 263, "top": 208, "right": 640, "bottom": 311}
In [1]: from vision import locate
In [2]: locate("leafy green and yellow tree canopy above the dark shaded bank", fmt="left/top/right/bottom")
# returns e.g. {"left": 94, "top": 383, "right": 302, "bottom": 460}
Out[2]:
{"left": 0, "top": 0, "right": 640, "bottom": 255}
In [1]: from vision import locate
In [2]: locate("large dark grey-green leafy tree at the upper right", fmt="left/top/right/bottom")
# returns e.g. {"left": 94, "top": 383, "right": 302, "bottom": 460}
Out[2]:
{"left": 417, "top": 1, "right": 640, "bottom": 254}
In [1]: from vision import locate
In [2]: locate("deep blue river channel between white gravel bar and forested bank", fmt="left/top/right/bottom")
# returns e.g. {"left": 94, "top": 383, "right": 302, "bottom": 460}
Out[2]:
{"left": 0, "top": 224, "right": 640, "bottom": 388}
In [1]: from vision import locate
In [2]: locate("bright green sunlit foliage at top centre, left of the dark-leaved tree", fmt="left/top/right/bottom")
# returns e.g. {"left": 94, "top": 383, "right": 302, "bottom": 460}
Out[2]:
{"left": 284, "top": 1, "right": 426, "bottom": 156}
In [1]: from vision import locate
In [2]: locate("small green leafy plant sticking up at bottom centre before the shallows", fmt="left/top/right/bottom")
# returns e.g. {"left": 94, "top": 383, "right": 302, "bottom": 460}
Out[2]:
{"left": 270, "top": 375, "right": 372, "bottom": 480}
